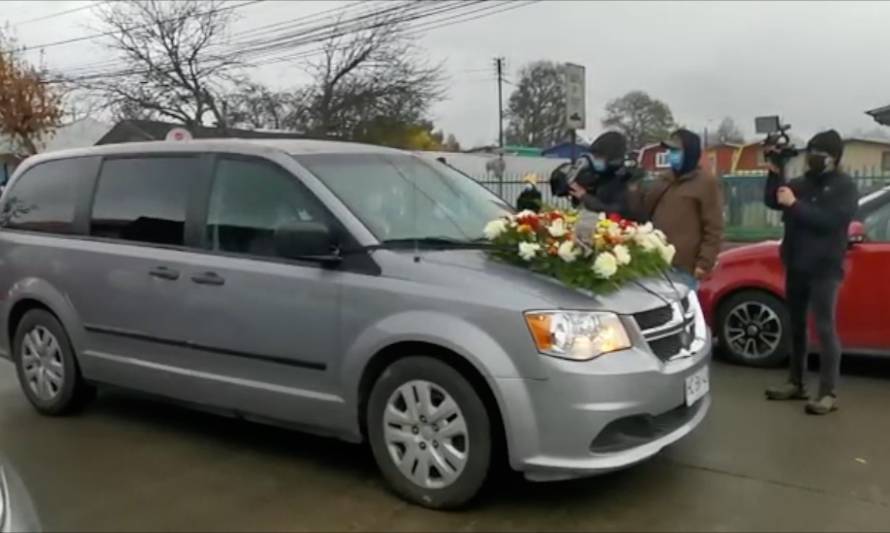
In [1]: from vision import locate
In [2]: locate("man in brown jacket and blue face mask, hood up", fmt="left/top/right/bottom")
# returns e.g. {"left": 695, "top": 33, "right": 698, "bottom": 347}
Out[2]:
{"left": 635, "top": 129, "right": 723, "bottom": 280}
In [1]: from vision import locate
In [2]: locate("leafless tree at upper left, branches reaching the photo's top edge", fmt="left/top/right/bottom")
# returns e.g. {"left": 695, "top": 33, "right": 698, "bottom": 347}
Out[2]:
{"left": 87, "top": 0, "right": 239, "bottom": 127}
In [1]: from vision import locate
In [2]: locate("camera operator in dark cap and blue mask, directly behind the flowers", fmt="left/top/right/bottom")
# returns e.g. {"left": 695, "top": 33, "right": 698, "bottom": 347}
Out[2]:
{"left": 568, "top": 131, "right": 637, "bottom": 220}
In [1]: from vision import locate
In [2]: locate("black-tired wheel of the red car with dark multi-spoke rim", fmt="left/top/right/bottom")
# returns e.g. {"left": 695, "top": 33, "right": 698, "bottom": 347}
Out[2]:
{"left": 716, "top": 290, "right": 791, "bottom": 367}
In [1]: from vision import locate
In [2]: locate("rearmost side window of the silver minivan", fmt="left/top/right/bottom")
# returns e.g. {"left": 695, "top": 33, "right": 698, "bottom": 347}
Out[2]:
{"left": 0, "top": 157, "right": 95, "bottom": 233}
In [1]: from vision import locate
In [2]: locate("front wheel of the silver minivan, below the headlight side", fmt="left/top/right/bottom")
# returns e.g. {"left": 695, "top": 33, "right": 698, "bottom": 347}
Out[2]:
{"left": 367, "top": 357, "right": 492, "bottom": 509}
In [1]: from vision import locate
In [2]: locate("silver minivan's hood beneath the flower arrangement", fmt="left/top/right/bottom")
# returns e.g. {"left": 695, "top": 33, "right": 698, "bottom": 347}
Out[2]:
{"left": 376, "top": 250, "right": 688, "bottom": 314}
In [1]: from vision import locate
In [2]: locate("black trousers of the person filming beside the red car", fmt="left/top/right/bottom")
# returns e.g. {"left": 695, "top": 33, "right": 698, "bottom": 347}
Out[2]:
{"left": 785, "top": 271, "right": 841, "bottom": 398}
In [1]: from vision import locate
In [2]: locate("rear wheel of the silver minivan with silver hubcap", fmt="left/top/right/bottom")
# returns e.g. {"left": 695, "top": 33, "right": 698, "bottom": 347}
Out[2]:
{"left": 13, "top": 309, "right": 95, "bottom": 416}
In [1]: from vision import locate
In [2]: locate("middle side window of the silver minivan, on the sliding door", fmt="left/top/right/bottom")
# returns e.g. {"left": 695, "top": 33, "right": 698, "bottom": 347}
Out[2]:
{"left": 90, "top": 156, "right": 201, "bottom": 246}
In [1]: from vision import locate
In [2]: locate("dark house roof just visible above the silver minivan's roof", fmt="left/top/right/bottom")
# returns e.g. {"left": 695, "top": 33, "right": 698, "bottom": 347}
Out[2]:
{"left": 96, "top": 120, "right": 310, "bottom": 145}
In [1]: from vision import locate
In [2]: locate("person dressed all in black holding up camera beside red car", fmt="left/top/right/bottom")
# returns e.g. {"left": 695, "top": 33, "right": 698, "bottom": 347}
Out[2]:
{"left": 754, "top": 130, "right": 859, "bottom": 414}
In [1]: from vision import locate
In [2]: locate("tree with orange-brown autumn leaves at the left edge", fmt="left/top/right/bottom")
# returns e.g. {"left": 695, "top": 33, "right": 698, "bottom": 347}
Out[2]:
{"left": 0, "top": 28, "right": 64, "bottom": 155}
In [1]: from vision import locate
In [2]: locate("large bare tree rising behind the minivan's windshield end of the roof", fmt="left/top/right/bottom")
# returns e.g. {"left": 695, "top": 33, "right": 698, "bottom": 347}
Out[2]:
{"left": 294, "top": 12, "right": 444, "bottom": 141}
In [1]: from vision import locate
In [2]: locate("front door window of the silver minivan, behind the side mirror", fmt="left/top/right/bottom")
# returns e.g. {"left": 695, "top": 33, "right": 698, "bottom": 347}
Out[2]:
{"left": 206, "top": 158, "right": 329, "bottom": 257}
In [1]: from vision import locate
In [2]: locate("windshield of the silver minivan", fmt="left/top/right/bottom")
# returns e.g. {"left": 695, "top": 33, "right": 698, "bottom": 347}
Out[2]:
{"left": 296, "top": 154, "right": 510, "bottom": 242}
